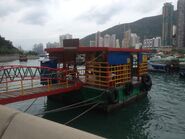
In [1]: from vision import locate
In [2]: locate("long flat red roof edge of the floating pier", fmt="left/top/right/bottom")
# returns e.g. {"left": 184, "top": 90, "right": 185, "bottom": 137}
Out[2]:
{"left": 45, "top": 46, "right": 150, "bottom": 53}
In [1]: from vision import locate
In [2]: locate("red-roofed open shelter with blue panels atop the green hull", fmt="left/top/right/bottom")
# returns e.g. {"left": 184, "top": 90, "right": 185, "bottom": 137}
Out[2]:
{"left": 46, "top": 39, "right": 148, "bottom": 88}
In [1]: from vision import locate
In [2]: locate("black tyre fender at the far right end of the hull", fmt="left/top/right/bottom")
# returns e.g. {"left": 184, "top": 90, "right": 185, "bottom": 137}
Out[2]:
{"left": 141, "top": 74, "right": 152, "bottom": 91}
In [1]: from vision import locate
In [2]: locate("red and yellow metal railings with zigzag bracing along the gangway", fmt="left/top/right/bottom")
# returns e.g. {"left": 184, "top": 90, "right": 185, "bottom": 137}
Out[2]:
{"left": 0, "top": 65, "right": 77, "bottom": 97}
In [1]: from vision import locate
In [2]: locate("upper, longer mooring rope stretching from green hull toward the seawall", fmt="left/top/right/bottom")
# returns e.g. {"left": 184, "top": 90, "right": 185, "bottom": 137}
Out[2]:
{"left": 35, "top": 92, "right": 105, "bottom": 116}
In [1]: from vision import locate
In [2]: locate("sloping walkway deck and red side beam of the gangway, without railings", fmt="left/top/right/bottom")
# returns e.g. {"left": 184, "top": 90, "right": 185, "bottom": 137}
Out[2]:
{"left": 0, "top": 83, "right": 82, "bottom": 104}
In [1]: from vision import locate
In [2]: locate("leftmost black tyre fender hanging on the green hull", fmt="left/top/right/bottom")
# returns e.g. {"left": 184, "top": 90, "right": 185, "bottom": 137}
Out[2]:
{"left": 106, "top": 88, "right": 118, "bottom": 104}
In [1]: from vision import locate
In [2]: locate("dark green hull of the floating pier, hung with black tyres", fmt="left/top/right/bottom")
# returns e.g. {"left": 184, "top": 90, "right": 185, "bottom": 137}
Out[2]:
{"left": 48, "top": 84, "right": 148, "bottom": 112}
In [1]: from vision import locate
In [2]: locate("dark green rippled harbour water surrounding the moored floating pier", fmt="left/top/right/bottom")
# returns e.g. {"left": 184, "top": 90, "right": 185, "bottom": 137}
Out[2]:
{"left": 0, "top": 60, "right": 185, "bottom": 139}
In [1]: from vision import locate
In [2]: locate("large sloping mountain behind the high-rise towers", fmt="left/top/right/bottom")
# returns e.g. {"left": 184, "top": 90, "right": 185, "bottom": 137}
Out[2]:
{"left": 80, "top": 11, "right": 177, "bottom": 46}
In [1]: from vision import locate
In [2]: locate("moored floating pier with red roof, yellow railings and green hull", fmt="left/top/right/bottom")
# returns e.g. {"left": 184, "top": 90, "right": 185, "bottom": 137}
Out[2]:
{"left": 41, "top": 39, "right": 152, "bottom": 112}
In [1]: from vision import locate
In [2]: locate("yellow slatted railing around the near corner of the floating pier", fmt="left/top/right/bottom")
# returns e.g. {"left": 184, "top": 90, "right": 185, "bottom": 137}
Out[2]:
{"left": 85, "top": 62, "right": 131, "bottom": 88}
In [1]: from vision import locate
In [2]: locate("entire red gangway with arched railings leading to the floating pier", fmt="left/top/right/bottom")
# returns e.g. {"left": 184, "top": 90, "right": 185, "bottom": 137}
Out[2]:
{"left": 0, "top": 65, "right": 82, "bottom": 104}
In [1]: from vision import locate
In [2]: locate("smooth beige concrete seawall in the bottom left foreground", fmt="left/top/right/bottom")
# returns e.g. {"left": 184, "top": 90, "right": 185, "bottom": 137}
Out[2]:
{"left": 0, "top": 105, "right": 102, "bottom": 139}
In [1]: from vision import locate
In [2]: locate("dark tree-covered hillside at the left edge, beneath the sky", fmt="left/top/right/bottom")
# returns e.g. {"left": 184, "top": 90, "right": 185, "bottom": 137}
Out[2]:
{"left": 0, "top": 36, "right": 19, "bottom": 55}
